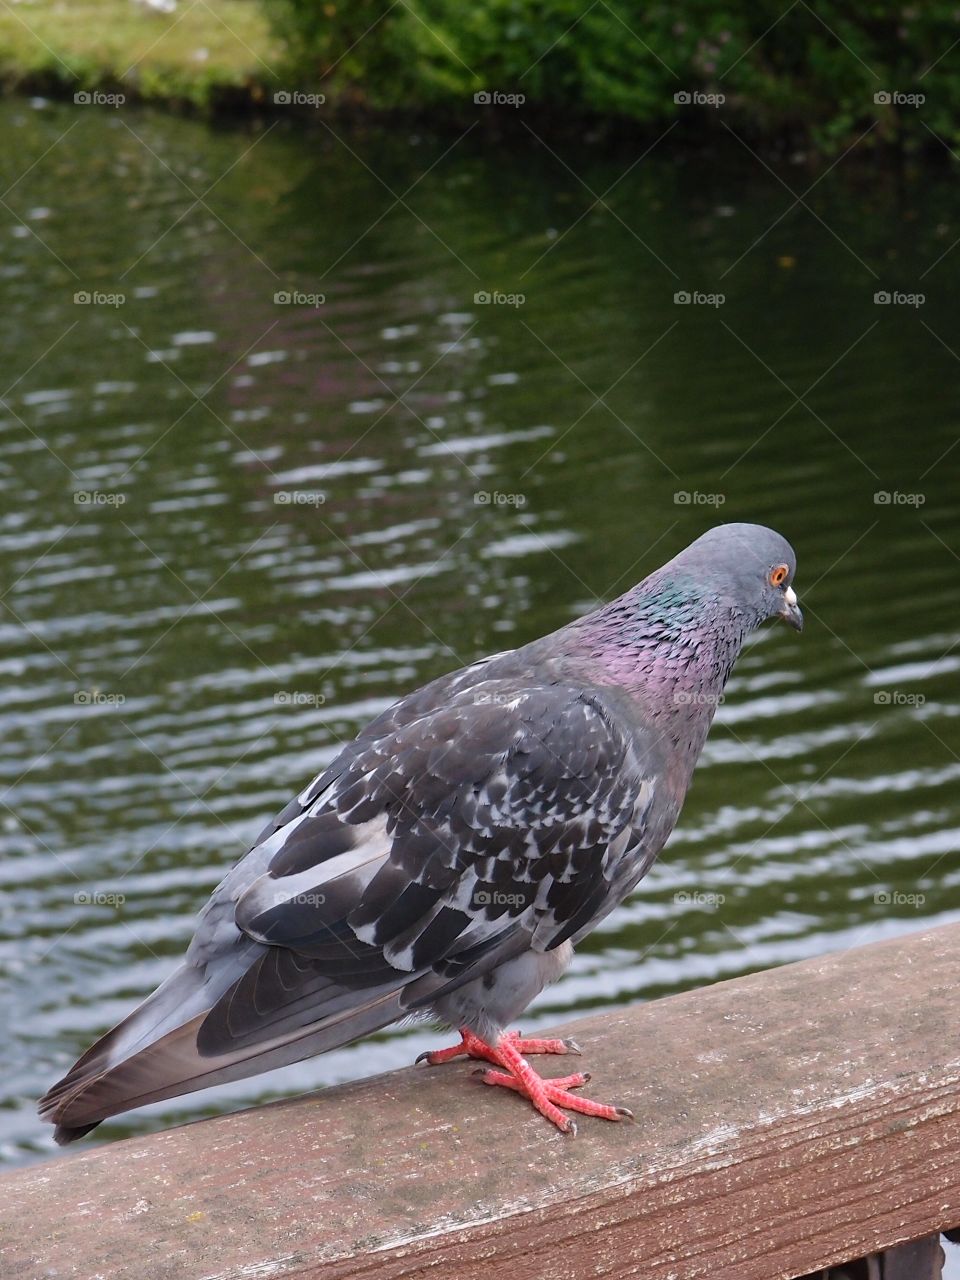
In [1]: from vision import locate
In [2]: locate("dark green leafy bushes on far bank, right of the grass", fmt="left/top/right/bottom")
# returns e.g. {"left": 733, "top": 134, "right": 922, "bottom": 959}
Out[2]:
{"left": 264, "top": 0, "right": 960, "bottom": 150}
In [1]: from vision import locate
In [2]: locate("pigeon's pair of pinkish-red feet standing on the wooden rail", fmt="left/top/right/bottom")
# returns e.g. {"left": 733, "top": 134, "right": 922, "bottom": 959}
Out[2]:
{"left": 417, "top": 1027, "right": 634, "bottom": 1134}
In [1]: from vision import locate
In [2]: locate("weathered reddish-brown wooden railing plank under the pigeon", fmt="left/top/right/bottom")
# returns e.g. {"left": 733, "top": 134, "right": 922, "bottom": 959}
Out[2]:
{"left": 0, "top": 925, "right": 960, "bottom": 1280}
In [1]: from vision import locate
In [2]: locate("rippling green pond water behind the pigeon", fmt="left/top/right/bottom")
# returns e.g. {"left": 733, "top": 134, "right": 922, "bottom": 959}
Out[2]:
{"left": 0, "top": 102, "right": 960, "bottom": 1198}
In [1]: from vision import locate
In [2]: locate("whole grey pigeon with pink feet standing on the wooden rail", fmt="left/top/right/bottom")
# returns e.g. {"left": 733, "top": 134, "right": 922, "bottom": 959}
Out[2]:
{"left": 40, "top": 524, "right": 803, "bottom": 1143}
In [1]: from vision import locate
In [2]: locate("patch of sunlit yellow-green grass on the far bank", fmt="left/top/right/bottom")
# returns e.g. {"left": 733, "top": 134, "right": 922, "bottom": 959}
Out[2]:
{"left": 0, "top": 0, "right": 282, "bottom": 109}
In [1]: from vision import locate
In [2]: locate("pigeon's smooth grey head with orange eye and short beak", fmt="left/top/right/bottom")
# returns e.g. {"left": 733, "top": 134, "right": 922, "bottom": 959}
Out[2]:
{"left": 673, "top": 525, "right": 804, "bottom": 631}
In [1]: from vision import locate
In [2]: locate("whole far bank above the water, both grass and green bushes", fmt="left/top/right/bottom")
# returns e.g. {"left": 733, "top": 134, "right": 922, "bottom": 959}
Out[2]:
{"left": 0, "top": 0, "right": 960, "bottom": 156}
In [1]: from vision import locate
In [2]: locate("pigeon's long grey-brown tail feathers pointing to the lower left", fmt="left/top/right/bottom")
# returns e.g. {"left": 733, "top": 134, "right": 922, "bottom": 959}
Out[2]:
{"left": 40, "top": 965, "right": 404, "bottom": 1144}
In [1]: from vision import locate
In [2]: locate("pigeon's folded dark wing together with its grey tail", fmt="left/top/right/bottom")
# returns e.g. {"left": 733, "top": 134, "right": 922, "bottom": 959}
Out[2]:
{"left": 41, "top": 672, "right": 662, "bottom": 1142}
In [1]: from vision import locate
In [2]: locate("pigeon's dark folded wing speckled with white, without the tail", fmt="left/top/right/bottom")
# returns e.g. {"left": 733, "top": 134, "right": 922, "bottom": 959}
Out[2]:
{"left": 217, "top": 681, "right": 653, "bottom": 1039}
